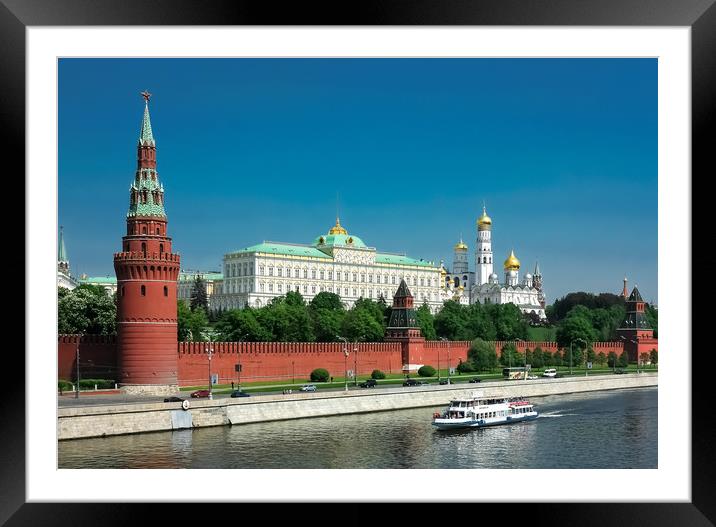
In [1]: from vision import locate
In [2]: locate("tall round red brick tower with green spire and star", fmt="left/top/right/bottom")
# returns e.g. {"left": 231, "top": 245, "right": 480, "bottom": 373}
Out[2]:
{"left": 114, "top": 91, "right": 179, "bottom": 394}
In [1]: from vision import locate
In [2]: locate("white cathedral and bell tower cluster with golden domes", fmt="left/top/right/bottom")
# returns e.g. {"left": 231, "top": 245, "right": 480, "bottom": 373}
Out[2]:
{"left": 445, "top": 207, "right": 547, "bottom": 321}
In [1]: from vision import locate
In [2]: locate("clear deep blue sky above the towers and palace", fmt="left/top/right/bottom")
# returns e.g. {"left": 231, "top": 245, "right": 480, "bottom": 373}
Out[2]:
{"left": 58, "top": 59, "right": 658, "bottom": 303}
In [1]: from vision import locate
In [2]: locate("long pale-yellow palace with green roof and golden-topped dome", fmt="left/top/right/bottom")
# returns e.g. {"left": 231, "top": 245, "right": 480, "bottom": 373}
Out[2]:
{"left": 211, "top": 218, "right": 469, "bottom": 312}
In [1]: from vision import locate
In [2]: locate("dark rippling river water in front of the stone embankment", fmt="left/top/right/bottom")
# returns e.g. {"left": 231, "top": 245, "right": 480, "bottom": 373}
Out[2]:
{"left": 58, "top": 388, "right": 658, "bottom": 469}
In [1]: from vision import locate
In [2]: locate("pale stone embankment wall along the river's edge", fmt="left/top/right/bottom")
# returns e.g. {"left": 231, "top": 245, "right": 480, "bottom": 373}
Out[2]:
{"left": 57, "top": 373, "right": 658, "bottom": 440}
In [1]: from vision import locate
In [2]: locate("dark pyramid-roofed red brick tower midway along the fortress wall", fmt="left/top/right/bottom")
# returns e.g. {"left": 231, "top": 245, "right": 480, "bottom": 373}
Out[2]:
{"left": 385, "top": 280, "right": 425, "bottom": 372}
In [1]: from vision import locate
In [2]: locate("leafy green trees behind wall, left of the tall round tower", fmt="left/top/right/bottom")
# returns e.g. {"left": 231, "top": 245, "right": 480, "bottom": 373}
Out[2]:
{"left": 57, "top": 285, "right": 117, "bottom": 335}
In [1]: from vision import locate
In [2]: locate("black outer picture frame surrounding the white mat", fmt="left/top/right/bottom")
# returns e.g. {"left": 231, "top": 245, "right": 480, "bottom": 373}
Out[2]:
{"left": 5, "top": 0, "right": 716, "bottom": 526}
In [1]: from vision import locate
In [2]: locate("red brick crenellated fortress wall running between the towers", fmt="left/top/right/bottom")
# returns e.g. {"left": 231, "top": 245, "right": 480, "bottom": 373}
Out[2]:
{"left": 58, "top": 335, "right": 624, "bottom": 386}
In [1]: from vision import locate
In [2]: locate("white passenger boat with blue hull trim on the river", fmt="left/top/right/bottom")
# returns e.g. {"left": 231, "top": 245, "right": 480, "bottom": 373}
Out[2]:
{"left": 432, "top": 397, "right": 539, "bottom": 430}
